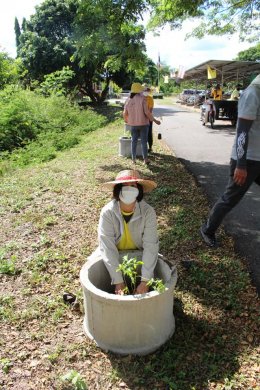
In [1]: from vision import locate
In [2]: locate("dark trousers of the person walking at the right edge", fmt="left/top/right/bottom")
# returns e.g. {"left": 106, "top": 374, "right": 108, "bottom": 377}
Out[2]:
{"left": 204, "top": 159, "right": 260, "bottom": 234}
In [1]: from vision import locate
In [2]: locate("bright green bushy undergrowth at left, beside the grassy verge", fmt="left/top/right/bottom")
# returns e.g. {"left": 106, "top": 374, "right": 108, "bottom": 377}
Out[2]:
{"left": 0, "top": 87, "right": 106, "bottom": 158}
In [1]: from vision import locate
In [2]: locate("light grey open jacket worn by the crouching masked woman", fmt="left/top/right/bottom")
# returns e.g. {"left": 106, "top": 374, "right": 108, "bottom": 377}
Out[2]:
{"left": 98, "top": 200, "right": 159, "bottom": 284}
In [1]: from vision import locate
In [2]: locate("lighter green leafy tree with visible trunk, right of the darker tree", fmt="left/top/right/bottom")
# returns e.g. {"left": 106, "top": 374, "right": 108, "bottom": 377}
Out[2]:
{"left": 74, "top": 0, "right": 146, "bottom": 102}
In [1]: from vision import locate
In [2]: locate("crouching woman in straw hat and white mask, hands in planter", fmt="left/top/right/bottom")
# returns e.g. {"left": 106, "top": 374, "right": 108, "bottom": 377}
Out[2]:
{"left": 98, "top": 170, "right": 159, "bottom": 295}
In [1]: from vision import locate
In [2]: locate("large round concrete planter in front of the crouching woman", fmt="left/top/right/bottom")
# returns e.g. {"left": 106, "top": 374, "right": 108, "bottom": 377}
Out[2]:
{"left": 80, "top": 251, "right": 177, "bottom": 355}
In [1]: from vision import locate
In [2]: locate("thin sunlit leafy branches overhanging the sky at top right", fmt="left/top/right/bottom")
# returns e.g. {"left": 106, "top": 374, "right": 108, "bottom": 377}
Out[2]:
{"left": 149, "top": 0, "right": 260, "bottom": 41}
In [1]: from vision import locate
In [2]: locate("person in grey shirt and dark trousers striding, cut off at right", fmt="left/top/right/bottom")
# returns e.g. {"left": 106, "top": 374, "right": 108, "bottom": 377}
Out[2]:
{"left": 200, "top": 74, "right": 260, "bottom": 247}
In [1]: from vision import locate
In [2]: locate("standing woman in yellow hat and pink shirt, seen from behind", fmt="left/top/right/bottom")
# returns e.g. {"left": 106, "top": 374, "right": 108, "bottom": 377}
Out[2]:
{"left": 123, "top": 83, "right": 161, "bottom": 164}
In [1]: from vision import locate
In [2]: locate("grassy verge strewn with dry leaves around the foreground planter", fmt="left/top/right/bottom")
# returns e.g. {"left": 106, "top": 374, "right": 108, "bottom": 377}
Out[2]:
{"left": 0, "top": 120, "right": 259, "bottom": 390}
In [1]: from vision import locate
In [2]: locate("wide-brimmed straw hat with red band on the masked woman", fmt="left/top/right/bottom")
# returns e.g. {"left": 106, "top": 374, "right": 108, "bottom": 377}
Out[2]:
{"left": 104, "top": 169, "right": 157, "bottom": 192}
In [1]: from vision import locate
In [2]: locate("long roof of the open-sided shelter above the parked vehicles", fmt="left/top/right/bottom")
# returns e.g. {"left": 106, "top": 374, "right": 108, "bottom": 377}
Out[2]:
{"left": 184, "top": 60, "right": 260, "bottom": 84}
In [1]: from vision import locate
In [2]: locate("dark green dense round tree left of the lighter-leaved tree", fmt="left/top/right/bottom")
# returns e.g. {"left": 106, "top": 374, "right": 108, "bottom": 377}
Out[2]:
{"left": 17, "top": 0, "right": 79, "bottom": 81}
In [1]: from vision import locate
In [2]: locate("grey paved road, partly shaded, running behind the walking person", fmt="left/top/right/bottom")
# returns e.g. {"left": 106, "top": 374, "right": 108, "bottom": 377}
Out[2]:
{"left": 154, "top": 105, "right": 260, "bottom": 295}
